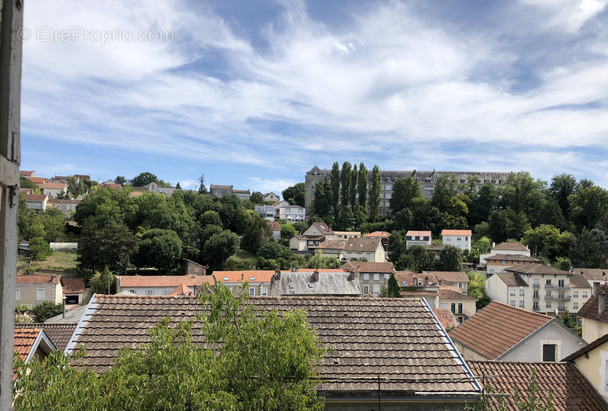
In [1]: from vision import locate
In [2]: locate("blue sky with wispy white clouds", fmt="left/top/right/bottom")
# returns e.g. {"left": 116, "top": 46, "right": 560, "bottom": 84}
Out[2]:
{"left": 21, "top": 0, "right": 608, "bottom": 194}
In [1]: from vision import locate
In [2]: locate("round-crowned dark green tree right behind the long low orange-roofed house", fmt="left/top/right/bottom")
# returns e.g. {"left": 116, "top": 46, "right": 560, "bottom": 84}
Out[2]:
{"left": 135, "top": 228, "right": 182, "bottom": 273}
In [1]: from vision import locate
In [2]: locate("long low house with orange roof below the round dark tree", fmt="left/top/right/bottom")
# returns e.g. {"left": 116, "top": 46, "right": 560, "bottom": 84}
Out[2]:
{"left": 116, "top": 275, "right": 207, "bottom": 295}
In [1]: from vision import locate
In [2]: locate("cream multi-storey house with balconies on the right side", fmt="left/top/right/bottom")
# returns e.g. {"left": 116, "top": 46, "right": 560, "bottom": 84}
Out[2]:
{"left": 486, "top": 264, "right": 591, "bottom": 314}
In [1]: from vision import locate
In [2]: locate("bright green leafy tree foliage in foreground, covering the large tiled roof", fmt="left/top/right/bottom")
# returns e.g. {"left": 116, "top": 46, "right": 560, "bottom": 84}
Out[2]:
{"left": 15, "top": 284, "right": 325, "bottom": 411}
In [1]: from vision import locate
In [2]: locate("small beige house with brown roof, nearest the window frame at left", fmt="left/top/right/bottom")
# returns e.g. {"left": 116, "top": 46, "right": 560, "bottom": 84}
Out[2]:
{"left": 15, "top": 275, "right": 63, "bottom": 308}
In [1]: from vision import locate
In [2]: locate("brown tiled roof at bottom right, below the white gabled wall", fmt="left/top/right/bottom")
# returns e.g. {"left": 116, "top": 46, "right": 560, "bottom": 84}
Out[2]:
{"left": 468, "top": 362, "right": 608, "bottom": 411}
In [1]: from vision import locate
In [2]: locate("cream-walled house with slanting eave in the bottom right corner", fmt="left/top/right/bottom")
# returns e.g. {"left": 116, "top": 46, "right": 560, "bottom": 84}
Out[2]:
{"left": 564, "top": 334, "right": 608, "bottom": 409}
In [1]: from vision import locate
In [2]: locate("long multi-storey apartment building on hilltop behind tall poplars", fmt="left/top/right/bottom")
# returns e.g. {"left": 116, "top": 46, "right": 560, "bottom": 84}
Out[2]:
{"left": 305, "top": 166, "right": 511, "bottom": 215}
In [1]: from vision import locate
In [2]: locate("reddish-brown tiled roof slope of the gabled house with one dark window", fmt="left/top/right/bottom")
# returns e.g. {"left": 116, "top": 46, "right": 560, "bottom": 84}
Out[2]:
{"left": 450, "top": 301, "right": 552, "bottom": 360}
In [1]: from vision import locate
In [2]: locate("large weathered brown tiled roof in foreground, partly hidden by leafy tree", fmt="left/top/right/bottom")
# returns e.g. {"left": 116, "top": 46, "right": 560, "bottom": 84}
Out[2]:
{"left": 70, "top": 295, "right": 478, "bottom": 395}
